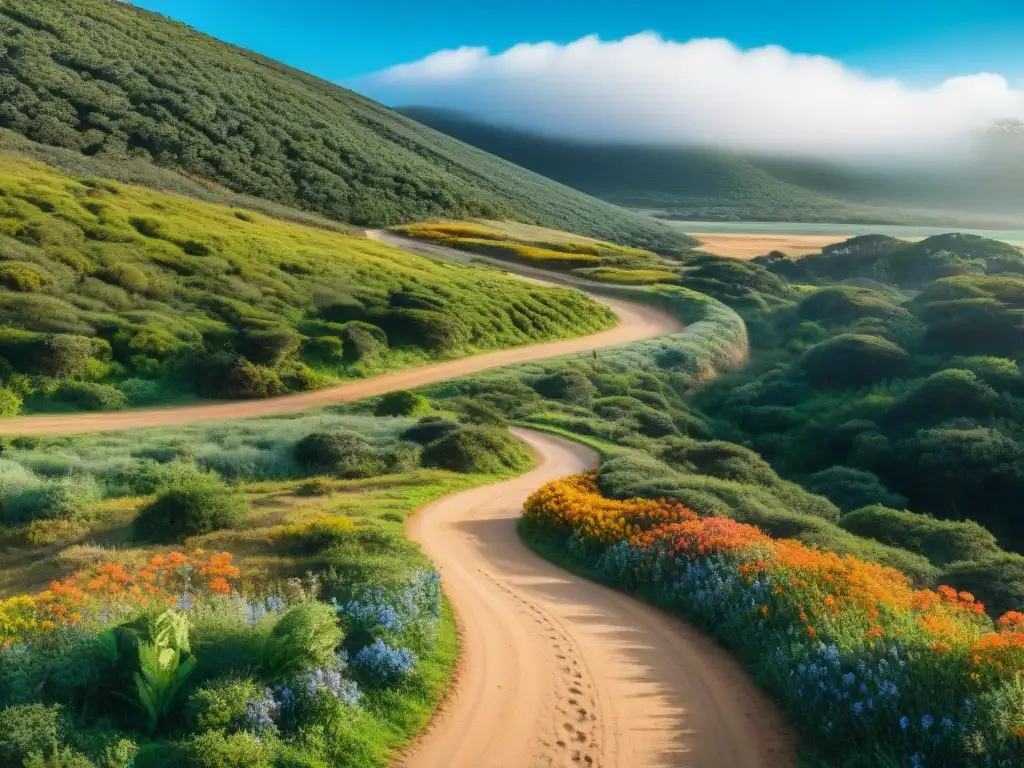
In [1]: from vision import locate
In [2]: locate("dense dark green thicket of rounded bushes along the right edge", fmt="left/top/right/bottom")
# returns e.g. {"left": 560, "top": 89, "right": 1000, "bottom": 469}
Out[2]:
{"left": 695, "top": 234, "right": 1024, "bottom": 611}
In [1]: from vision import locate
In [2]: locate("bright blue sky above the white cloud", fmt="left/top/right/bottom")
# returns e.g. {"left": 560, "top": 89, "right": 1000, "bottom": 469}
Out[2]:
{"left": 134, "top": 0, "right": 1024, "bottom": 84}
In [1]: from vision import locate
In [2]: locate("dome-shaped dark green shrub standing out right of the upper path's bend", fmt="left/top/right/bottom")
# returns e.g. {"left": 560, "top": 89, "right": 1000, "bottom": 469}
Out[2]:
{"left": 802, "top": 334, "right": 910, "bottom": 389}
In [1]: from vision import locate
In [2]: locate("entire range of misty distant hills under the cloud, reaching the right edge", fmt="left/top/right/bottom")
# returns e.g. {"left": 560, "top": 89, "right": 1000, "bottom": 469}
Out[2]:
{"left": 400, "top": 106, "right": 1020, "bottom": 226}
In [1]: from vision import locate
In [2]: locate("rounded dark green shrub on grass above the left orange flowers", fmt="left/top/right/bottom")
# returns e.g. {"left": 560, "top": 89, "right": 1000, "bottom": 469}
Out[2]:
{"left": 135, "top": 475, "right": 249, "bottom": 542}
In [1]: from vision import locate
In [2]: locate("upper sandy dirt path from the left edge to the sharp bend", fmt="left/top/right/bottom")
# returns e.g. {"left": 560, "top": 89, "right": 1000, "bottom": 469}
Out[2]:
{"left": 0, "top": 270, "right": 683, "bottom": 434}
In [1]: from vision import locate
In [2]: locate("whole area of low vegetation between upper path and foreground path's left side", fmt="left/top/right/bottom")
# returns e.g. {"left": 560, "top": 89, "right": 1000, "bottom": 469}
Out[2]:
{"left": 0, "top": 409, "right": 529, "bottom": 768}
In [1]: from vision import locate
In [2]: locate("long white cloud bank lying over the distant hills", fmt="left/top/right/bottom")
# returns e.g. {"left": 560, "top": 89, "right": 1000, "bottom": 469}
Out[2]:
{"left": 352, "top": 33, "right": 1024, "bottom": 157}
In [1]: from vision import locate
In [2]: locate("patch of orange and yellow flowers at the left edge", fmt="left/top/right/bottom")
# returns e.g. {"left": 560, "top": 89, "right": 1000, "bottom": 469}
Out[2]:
{"left": 0, "top": 550, "right": 241, "bottom": 646}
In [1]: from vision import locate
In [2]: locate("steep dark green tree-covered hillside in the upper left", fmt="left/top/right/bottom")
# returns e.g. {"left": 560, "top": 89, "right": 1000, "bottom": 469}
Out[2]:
{"left": 0, "top": 0, "right": 689, "bottom": 249}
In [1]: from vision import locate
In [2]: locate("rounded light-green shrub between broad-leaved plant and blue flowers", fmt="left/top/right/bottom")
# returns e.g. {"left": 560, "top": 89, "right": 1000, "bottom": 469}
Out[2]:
{"left": 260, "top": 600, "right": 344, "bottom": 682}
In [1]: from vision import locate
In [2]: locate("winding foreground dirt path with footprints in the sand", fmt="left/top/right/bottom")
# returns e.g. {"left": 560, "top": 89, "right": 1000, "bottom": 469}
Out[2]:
{"left": 398, "top": 430, "right": 796, "bottom": 768}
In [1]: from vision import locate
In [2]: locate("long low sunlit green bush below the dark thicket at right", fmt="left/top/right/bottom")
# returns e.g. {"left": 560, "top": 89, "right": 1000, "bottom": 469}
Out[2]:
{"left": 839, "top": 505, "right": 999, "bottom": 566}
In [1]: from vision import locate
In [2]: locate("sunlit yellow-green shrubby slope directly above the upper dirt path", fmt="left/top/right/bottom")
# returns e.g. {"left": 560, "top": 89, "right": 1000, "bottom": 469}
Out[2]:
{"left": 0, "top": 158, "right": 611, "bottom": 415}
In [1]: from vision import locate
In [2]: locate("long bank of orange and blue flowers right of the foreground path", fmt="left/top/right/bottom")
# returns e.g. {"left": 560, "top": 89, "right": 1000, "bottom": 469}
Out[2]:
{"left": 524, "top": 475, "right": 1024, "bottom": 768}
